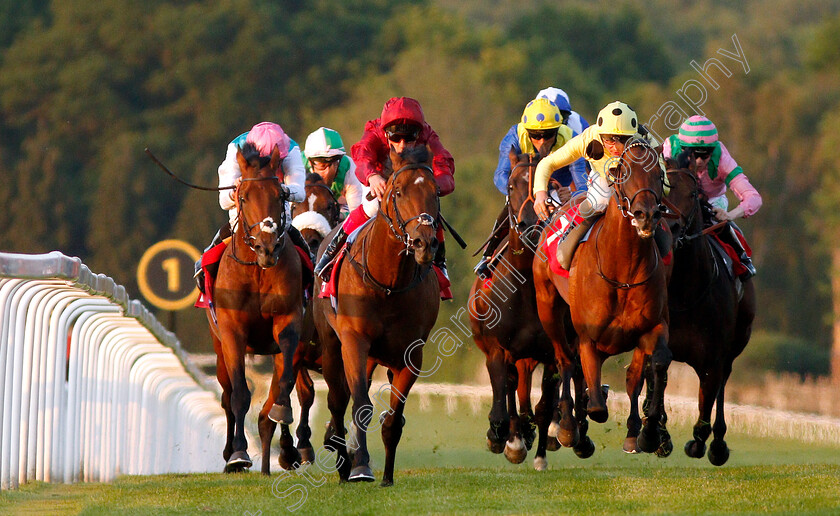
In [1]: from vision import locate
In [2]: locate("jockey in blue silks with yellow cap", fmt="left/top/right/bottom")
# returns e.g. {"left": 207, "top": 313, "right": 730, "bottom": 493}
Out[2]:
{"left": 474, "top": 96, "right": 586, "bottom": 276}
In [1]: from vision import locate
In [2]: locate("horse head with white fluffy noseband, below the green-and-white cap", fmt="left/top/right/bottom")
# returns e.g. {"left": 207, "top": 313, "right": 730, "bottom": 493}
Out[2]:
{"left": 292, "top": 174, "right": 341, "bottom": 254}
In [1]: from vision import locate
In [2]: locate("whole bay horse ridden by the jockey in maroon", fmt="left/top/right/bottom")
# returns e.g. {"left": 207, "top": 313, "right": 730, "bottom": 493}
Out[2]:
{"left": 314, "top": 147, "right": 440, "bottom": 486}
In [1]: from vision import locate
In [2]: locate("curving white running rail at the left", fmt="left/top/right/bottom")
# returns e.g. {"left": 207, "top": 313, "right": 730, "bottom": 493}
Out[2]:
{"left": 0, "top": 252, "right": 226, "bottom": 489}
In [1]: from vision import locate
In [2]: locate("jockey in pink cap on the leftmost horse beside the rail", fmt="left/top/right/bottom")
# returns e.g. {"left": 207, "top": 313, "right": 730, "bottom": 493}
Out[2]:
{"left": 195, "top": 122, "right": 309, "bottom": 293}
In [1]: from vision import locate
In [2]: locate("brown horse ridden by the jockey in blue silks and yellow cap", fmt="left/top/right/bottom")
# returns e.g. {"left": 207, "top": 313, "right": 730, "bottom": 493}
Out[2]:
{"left": 469, "top": 149, "right": 594, "bottom": 471}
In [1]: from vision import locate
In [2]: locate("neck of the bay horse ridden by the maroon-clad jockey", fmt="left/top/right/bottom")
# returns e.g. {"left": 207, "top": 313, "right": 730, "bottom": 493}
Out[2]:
{"left": 356, "top": 214, "right": 424, "bottom": 288}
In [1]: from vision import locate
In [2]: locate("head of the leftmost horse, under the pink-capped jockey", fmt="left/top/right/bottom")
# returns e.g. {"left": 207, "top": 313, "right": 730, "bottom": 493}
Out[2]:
{"left": 236, "top": 143, "right": 289, "bottom": 269}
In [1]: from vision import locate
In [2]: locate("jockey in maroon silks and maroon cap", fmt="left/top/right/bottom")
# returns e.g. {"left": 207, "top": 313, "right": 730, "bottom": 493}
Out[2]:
{"left": 315, "top": 97, "right": 455, "bottom": 281}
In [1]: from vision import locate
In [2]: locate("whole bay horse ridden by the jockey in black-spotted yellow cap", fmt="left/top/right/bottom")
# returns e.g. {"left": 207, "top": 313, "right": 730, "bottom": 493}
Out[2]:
{"left": 534, "top": 139, "right": 671, "bottom": 455}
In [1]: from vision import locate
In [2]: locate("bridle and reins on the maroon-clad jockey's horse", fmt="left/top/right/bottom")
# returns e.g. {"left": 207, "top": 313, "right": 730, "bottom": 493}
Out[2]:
{"left": 347, "top": 163, "right": 440, "bottom": 296}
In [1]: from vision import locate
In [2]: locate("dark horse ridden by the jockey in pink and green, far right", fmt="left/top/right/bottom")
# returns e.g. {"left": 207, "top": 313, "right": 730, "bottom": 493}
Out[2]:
{"left": 626, "top": 159, "right": 756, "bottom": 466}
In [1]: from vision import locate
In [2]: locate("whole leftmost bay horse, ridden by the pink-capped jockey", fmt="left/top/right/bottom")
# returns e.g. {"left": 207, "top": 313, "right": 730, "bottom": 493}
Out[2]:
{"left": 207, "top": 143, "right": 303, "bottom": 474}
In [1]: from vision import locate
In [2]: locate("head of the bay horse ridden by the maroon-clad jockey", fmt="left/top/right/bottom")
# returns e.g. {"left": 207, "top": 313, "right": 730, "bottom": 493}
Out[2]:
{"left": 380, "top": 147, "right": 440, "bottom": 265}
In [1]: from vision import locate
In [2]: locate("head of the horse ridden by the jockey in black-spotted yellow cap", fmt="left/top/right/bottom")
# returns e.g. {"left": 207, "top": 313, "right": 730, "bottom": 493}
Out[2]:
{"left": 611, "top": 139, "right": 664, "bottom": 239}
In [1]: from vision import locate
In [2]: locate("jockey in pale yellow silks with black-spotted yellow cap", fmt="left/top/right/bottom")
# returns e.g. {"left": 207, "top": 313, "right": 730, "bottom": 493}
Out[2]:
{"left": 534, "top": 101, "right": 670, "bottom": 270}
